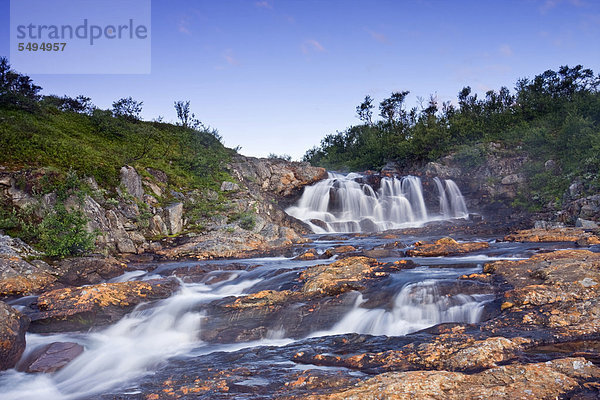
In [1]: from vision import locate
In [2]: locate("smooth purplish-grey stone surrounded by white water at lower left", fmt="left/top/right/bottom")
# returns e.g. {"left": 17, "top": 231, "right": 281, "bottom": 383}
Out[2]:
{"left": 17, "top": 342, "right": 83, "bottom": 373}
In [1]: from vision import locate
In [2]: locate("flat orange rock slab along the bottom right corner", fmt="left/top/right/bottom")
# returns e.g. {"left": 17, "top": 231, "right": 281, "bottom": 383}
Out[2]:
{"left": 305, "top": 358, "right": 600, "bottom": 400}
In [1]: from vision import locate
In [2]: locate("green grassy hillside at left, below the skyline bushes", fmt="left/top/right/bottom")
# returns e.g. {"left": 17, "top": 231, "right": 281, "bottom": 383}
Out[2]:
{"left": 0, "top": 106, "right": 229, "bottom": 188}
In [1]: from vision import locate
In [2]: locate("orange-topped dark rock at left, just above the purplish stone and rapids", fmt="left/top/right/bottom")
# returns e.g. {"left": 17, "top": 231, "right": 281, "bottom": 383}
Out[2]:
{"left": 30, "top": 279, "right": 178, "bottom": 332}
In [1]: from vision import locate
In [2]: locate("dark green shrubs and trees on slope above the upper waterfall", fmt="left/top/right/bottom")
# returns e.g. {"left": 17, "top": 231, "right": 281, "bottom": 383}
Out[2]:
{"left": 304, "top": 65, "right": 600, "bottom": 208}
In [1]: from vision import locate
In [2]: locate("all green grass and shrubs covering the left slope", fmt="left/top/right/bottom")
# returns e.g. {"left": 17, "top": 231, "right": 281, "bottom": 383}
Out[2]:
{"left": 0, "top": 58, "right": 232, "bottom": 256}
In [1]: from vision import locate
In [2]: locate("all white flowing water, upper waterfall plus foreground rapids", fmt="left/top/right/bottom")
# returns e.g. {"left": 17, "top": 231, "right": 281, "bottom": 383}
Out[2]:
{"left": 0, "top": 174, "right": 540, "bottom": 400}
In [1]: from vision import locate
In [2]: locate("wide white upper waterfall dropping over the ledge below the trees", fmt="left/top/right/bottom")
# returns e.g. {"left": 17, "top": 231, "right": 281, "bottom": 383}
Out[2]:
{"left": 286, "top": 173, "right": 468, "bottom": 233}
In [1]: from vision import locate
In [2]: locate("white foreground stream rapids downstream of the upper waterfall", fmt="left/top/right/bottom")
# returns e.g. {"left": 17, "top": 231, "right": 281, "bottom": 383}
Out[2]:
{"left": 0, "top": 242, "right": 532, "bottom": 400}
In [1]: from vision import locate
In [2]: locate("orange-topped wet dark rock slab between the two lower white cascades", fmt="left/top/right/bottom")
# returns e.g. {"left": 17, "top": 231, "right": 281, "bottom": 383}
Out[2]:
{"left": 200, "top": 257, "right": 415, "bottom": 343}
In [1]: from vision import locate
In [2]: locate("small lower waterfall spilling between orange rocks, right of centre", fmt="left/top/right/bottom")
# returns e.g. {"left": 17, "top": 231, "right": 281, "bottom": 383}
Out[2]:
{"left": 314, "top": 279, "right": 493, "bottom": 336}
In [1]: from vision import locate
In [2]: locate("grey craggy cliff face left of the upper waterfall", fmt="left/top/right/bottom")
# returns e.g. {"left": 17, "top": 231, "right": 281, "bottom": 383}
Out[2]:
{"left": 0, "top": 155, "right": 326, "bottom": 257}
